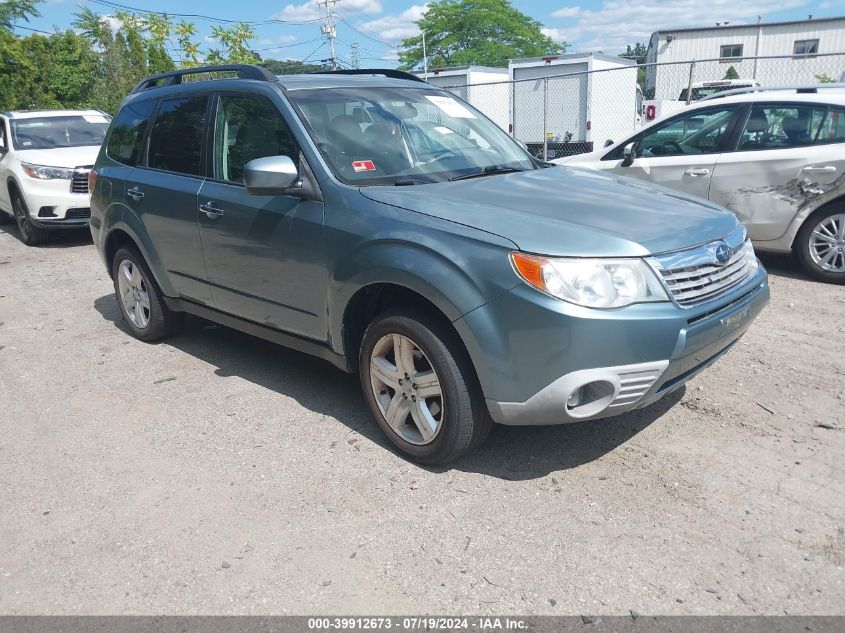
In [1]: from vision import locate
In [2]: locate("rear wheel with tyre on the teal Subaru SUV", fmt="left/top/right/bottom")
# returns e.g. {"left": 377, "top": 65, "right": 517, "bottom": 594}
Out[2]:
{"left": 112, "top": 246, "right": 184, "bottom": 341}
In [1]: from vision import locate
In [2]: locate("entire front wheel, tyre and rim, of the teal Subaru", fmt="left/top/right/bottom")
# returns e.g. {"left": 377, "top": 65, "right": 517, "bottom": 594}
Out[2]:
{"left": 359, "top": 312, "right": 492, "bottom": 465}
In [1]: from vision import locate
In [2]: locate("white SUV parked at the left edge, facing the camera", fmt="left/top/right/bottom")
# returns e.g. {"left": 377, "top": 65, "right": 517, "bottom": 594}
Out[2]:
{"left": 0, "top": 110, "right": 111, "bottom": 245}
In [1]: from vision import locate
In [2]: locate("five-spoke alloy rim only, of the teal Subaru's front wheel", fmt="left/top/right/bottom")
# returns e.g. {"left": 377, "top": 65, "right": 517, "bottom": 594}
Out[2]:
{"left": 370, "top": 334, "right": 444, "bottom": 446}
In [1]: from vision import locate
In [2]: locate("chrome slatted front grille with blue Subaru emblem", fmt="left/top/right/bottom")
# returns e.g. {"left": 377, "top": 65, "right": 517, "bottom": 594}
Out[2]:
{"left": 650, "top": 228, "right": 757, "bottom": 307}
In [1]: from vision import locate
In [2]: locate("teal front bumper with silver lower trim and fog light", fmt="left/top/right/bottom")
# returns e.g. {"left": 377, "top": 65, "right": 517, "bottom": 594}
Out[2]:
{"left": 455, "top": 267, "right": 769, "bottom": 425}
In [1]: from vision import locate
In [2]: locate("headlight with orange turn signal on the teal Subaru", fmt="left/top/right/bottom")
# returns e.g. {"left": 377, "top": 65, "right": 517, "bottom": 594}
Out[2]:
{"left": 511, "top": 252, "right": 669, "bottom": 308}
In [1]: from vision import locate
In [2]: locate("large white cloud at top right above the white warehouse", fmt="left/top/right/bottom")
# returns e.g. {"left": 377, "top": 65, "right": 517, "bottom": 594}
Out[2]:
{"left": 547, "top": 0, "right": 807, "bottom": 53}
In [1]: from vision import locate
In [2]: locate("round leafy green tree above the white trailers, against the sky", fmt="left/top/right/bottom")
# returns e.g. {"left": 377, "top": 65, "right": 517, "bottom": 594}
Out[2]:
{"left": 399, "top": 0, "right": 566, "bottom": 69}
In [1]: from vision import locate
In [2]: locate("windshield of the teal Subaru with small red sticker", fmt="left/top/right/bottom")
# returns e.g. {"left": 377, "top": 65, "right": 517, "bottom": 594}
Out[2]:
{"left": 287, "top": 88, "right": 535, "bottom": 185}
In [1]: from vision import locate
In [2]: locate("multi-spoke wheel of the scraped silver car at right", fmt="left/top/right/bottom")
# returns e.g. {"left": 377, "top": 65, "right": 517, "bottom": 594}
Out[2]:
{"left": 797, "top": 204, "right": 845, "bottom": 284}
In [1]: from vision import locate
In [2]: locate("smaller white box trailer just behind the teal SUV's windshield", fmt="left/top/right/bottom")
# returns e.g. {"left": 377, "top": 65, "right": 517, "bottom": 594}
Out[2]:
{"left": 414, "top": 66, "right": 510, "bottom": 131}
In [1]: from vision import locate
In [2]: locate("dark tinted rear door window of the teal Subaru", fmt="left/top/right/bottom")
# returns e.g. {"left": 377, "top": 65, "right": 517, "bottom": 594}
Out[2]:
{"left": 147, "top": 95, "right": 209, "bottom": 176}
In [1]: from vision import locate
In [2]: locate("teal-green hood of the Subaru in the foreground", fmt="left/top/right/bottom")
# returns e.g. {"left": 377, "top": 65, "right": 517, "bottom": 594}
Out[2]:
{"left": 361, "top": 167, "right": 738, "bottom": 257}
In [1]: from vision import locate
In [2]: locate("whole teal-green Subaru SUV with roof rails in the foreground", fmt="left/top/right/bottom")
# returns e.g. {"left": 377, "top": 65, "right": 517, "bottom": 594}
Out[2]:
{"left": 90, "top": 66, "right": 769, "bottom": 464}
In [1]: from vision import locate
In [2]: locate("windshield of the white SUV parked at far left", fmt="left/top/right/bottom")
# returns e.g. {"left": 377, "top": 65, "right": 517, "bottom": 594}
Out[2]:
{"left": 11, "top": 114, "right": 109, "bottom": 149}
